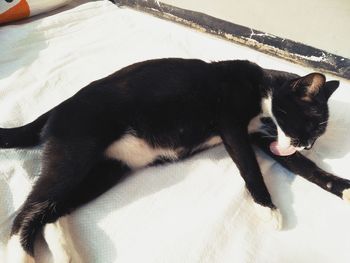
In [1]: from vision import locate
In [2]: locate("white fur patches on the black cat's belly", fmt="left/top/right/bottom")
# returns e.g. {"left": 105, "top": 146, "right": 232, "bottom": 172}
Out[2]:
{"left": 105, "top": 134, "right": 221, "bottom": 169}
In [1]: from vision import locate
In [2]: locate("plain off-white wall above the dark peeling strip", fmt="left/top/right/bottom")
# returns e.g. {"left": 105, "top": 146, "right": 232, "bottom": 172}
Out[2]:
{"left": 161, "top": 0, "right": 350, "bottom": 58}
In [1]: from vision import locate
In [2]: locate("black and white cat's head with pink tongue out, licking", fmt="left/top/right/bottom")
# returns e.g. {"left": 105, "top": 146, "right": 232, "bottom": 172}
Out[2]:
{"left": 270, "top": 73, "right": 339, "bottom": 155}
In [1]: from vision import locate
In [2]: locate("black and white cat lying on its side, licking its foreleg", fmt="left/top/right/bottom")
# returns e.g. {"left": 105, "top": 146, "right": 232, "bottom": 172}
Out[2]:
{"left": 0, "top": 59, "right": 350, "bottom": 262}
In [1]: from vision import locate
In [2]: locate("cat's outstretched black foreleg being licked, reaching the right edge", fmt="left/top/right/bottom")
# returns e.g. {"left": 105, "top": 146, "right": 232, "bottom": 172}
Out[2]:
{"left": 251, "top": 134, "right": 350, "bottom": 202}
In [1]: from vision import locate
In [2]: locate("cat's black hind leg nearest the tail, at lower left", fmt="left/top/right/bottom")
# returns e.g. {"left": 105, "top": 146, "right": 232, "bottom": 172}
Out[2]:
{"left": 11, "top": 138, "right": 102, "bottom": 262}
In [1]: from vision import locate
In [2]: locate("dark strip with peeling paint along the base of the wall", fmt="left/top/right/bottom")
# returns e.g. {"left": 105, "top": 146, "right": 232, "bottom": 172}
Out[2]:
{"left": 115, "top": 0, "right": 350, "bottom": 79}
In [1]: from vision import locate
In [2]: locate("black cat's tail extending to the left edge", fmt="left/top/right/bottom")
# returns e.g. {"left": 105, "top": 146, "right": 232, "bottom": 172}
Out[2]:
{"left": 0, "top": 110, "right": 52, "bottom": 148}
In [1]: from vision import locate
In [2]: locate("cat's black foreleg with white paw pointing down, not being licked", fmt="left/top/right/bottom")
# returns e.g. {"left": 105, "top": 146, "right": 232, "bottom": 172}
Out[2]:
{"left": 221, "top": 122, "right": 282, "bottom": 229}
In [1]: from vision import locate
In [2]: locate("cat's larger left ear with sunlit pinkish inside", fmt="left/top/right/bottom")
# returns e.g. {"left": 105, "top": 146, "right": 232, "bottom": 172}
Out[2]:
{"left": 291, "top": 73, "right": 326, "bottom": 101}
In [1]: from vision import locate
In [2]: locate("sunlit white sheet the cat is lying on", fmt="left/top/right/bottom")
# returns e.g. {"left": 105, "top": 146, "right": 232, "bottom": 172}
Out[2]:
{"left": 0, "top": 1, "right": 350, "bottom": 263}
